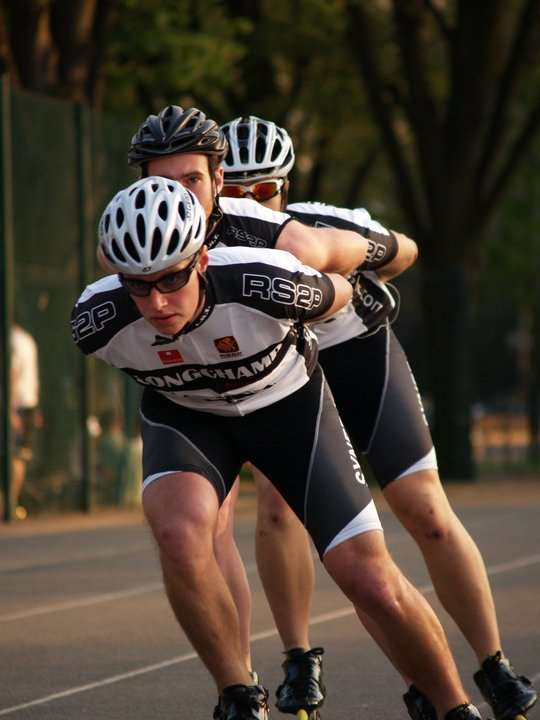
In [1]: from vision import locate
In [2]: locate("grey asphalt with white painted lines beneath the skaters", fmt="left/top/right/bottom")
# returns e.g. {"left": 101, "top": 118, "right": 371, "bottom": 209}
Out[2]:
{"left": 0, "top": 480, "right": 540, "bottom": 720}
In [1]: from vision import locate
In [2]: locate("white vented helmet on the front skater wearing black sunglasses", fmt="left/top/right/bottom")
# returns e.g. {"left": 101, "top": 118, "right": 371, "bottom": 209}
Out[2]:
{"left": 98, "top": 176, "right": 206, "bottom": 275}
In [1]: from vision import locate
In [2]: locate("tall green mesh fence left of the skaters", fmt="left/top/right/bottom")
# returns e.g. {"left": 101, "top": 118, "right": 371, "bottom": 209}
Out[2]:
{"left": 2, "top": 84, "right": 140, "bottom": 514}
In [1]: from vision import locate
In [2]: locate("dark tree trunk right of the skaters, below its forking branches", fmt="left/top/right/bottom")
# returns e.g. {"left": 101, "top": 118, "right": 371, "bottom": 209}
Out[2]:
{"left": 422, "top": 261, "right": 475, "bottom": 481}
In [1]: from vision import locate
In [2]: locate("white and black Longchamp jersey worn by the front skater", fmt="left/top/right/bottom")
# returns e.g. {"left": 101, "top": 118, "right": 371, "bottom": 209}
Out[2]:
{"left": 72, "top": 247, "right": 334, "bottom": 416}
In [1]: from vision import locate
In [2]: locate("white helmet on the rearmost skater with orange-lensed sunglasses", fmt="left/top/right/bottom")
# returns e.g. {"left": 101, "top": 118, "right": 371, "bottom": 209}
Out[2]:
{"left": 221, "top": 115, "right": 294, "bottom": 184}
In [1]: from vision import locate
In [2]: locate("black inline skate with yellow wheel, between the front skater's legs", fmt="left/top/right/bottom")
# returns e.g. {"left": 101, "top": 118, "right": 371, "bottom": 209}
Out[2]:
{"left": 276, "top": 648, "right": 326, "bottom": 720}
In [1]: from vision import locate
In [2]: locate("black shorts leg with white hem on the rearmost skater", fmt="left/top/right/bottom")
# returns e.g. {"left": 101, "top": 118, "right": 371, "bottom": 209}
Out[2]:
{"left": 319, "top": 325, "right": 437, "bottom": 488}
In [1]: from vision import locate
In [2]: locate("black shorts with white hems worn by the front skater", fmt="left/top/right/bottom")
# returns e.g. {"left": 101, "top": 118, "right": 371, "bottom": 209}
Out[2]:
{"left": 141, "top": 367, "right": 381, "bottom": 557}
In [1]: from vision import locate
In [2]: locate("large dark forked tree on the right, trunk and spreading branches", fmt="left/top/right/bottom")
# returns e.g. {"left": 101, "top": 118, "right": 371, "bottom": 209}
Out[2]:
{"left": 345, "top": 0, "right": 540, "bottom": 477}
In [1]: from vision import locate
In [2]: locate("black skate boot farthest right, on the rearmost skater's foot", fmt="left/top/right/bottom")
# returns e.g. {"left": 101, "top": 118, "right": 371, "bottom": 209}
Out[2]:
{"left": 474, "top": 651, "right": 538, "bottom": 720}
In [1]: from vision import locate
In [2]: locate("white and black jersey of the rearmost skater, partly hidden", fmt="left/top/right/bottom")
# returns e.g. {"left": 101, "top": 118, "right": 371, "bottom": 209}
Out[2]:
{"left": 286, "top": 203, "right": 395, "bottom": 350}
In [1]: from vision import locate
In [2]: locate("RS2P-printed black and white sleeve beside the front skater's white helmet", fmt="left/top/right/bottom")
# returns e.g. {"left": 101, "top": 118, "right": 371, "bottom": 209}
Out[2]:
{"left": 209, "top": 247, "right": 335, "bottom": 322}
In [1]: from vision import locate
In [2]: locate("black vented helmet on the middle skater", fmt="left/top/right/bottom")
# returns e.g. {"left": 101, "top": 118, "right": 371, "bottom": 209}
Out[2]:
{"left": 128, "top": 105, "right": 227, "bottom": 165}
